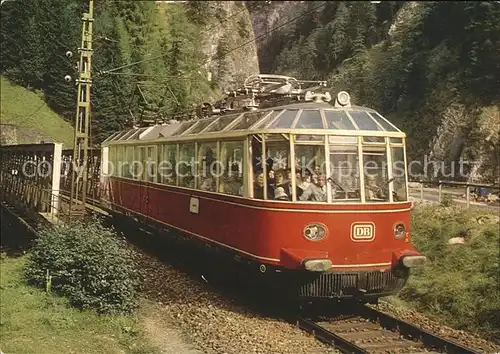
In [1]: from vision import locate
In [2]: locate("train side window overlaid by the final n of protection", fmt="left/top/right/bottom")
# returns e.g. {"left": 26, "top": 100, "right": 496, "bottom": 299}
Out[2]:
{"left": 219, "top": 141, "right": 245, "bottom": 196}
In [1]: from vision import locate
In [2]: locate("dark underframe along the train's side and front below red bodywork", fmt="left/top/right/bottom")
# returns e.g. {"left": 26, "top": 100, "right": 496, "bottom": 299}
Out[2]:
{"left": 109, "top": 207, "right": 409, "bottom": 303}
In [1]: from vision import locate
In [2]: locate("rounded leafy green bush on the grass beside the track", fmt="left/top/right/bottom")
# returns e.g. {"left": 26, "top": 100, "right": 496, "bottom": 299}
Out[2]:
{"left": 25, "top": 221, "right": 140, "bottom": 314}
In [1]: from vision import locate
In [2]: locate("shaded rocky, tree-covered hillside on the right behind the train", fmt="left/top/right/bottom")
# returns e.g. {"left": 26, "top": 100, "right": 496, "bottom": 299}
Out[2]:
{"left": 248, "top": 1, "right": 500, "bottom": 181}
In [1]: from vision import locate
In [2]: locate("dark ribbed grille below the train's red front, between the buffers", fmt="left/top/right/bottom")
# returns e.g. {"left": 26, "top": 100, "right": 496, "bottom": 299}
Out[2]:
{"left": 299, "top": 271, "right": 405, "bottom": 297}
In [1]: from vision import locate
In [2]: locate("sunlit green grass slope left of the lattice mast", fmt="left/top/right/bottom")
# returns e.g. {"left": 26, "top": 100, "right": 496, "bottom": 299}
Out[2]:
{"left": 0, "top": 76, "right": 76, "bottom": 149}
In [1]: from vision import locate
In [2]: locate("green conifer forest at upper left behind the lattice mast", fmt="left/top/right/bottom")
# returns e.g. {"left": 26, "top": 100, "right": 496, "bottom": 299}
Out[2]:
{"left": 0, "top": 0, "right": 217, "bottom": 144}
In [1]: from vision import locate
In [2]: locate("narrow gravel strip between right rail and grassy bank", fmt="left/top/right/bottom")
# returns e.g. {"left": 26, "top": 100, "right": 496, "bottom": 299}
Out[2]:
{"left": 373, "top": 301, "right": 500, "bottom": 353}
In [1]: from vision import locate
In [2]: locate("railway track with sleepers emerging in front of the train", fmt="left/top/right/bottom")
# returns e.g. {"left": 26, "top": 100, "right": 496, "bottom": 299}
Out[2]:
{"left": 297, "top": 306, "right": 480, "bottom": 354}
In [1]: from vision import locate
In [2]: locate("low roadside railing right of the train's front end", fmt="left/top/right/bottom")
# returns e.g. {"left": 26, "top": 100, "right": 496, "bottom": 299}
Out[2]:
{"left": 409, "top": 179, "right": 500, "bottom": 207}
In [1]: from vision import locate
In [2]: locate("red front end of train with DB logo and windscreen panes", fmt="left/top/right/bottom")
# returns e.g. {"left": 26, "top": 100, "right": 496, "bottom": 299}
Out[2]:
{"left": 250, "top": 93, "right": 426, "bottom": 301}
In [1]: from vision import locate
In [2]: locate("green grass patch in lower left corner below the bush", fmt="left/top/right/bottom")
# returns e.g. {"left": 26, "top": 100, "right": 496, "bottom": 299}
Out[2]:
{"left": 0, "top": 256, "right": 158, "bottom": 354}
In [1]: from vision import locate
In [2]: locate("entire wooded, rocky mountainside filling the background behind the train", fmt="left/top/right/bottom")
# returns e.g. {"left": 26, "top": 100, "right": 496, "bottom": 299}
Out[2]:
{"left": 0, "top": 0, "right": 500, "bottom": 180}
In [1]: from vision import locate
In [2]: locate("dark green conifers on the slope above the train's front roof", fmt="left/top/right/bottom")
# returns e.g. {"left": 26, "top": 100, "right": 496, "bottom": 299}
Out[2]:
{"left": 259, "top": 1, "right": 500, "bottom": 159}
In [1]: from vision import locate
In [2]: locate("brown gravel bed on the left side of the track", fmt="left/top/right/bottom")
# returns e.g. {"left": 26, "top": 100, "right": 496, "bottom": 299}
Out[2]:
{"left": 135, "top": 248, "right": 338, "bottom": 354}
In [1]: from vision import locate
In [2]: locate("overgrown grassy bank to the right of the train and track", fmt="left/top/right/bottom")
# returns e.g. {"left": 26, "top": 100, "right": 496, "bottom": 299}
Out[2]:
{"left": 399, "top": 203, "right": 500, "bottom": 342}
